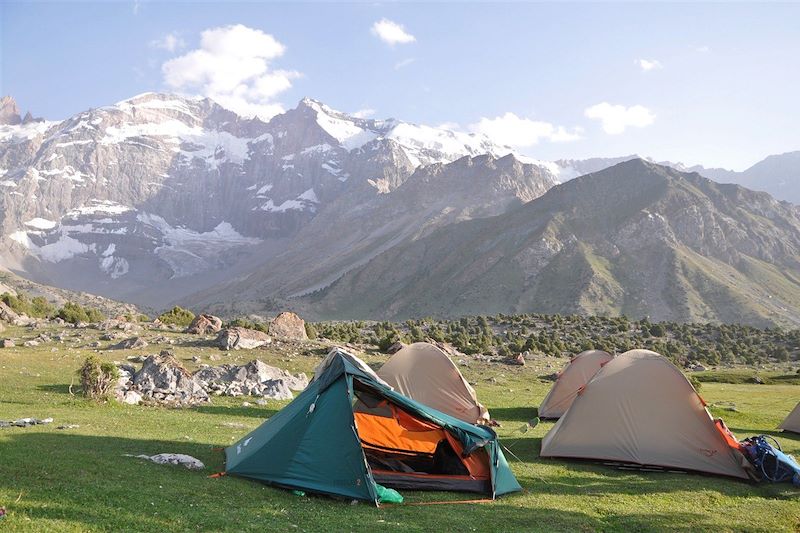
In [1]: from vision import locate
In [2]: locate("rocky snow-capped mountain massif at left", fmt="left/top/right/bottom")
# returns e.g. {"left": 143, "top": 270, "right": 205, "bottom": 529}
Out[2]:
{"left": 0, "top": 93, "right": 549, "bottom": 303}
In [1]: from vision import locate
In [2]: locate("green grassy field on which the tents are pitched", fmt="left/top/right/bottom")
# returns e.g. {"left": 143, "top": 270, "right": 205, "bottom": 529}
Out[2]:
{"left": 0, "top": 322, "right": 800, "bottom": 532}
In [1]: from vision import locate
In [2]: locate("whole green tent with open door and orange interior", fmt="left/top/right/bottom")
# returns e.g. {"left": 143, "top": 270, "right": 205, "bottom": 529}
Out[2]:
{"left": 225, "top": 349, "right": 521, "bottom": 504}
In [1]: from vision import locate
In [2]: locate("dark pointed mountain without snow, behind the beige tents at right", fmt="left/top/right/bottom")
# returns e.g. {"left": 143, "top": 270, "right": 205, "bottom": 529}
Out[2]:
{"left": 306, "top": 159, "right": 800, "bottom": 325}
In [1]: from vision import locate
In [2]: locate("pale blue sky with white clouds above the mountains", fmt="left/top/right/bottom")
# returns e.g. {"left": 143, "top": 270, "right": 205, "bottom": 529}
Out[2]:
{"left": 0, "top": 1, "right": 800, "bottom": 169}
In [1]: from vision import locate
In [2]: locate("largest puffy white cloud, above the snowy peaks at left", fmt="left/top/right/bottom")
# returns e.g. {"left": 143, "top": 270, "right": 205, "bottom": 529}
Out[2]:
{"left": 161, "top": 24, "right": 300, "bottom": 120}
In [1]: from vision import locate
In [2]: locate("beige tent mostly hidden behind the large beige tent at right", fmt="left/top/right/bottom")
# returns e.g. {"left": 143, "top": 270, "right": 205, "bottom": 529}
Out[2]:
{"left": 539, "top": 350, "right": 613, "bottom": 418}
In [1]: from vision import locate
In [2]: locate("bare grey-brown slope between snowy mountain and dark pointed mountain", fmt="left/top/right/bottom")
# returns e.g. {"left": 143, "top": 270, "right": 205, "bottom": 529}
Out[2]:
{"left": 183, "top": 155, "right": 555, "bottom": 313}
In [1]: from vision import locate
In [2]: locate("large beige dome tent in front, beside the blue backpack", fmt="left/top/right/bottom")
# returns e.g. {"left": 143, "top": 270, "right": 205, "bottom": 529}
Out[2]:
{"left": 541, "top": 350, "right": 748, "bottom": 478}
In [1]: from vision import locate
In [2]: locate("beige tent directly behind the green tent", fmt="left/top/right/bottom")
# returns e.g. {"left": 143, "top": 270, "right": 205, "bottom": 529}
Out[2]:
{"left": 378, "top": 342, "right": 489, "bottom": 424}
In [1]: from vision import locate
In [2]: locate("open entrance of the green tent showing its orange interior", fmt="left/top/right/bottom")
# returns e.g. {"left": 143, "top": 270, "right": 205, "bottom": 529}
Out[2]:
{"left": 353, "top": 381, "right": 491, "bottom": 493}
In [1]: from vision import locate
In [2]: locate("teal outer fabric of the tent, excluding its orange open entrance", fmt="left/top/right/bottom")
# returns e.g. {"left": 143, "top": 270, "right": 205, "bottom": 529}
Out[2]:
{"left": 225, "top": 351, "right": 521, "bottom": 504}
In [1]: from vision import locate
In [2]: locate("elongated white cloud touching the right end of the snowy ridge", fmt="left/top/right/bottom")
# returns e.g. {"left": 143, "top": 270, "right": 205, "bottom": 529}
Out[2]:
{"left": 469, "top": 112, "right": 582, "bottom": 148}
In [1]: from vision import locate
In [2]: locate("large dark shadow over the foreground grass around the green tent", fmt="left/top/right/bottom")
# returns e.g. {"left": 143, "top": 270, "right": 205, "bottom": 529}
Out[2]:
{"left": 0, "top": 430, "right": 796, "bottom": 531}
